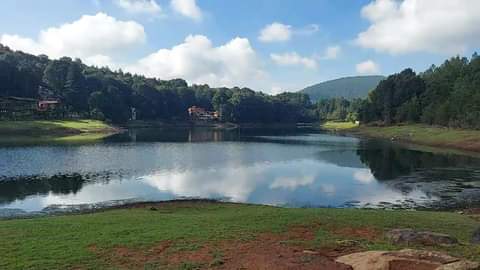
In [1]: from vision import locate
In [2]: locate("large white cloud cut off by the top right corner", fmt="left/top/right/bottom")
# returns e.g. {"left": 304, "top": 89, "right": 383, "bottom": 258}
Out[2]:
{"left": 356, "top": 0, "right": 480, "bottom": 54}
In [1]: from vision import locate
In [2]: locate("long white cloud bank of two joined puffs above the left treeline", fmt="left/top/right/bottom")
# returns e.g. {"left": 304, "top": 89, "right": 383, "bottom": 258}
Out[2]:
{"left": 0, "top": 13, "right": 271, "bottom": 90}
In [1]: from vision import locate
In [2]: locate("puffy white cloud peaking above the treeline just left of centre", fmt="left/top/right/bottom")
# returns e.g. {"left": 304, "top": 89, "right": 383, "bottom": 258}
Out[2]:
{"left": 127, "top": 35, "right": 264, "bottom": 87}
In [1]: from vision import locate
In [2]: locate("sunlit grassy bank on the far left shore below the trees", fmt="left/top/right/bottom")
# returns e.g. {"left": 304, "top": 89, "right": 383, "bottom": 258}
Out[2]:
{"left": 0, "top": 119, "right": 117, "bottom": 143}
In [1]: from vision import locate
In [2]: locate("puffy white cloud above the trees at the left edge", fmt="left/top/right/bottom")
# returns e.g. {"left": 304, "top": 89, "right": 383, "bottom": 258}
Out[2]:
{"left": 0, "top": 13, "right": 146, "bottom": 64}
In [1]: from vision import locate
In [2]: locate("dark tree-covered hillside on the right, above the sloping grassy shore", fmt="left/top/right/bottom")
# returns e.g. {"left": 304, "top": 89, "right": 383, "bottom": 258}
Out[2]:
{"left": 359, "top": 53, "right": 480, "bottom": 129}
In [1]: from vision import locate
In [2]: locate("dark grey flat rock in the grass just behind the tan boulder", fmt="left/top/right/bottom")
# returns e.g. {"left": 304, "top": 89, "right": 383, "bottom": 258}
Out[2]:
{"left": 386, "top": 229, "right": 458, "bottom": 246}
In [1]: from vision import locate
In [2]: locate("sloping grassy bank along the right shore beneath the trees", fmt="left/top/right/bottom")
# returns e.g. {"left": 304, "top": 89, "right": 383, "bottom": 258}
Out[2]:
{"left": 323, "top": 122, "right": 480, "bottom": 152}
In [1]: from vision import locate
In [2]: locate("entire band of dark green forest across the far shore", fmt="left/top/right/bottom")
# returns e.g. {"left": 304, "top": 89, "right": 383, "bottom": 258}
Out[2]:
{"left": 0, "top": 45, "right": 480, "bottom": 129}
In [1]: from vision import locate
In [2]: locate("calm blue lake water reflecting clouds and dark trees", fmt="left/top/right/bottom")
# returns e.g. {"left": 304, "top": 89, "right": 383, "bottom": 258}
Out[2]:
{"left": 0, "top": 129, "right": 480, "bottom": 216}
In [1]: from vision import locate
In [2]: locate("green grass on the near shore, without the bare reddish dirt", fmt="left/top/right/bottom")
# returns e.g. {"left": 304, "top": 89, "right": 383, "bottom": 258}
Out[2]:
{"left": 0, "top": 202, "right": 480, "bottom": 269}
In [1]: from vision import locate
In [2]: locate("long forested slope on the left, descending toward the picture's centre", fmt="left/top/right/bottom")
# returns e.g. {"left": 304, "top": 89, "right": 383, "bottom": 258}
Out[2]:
{"left": 0, "top": 45, "right": 316, "bottom": 123}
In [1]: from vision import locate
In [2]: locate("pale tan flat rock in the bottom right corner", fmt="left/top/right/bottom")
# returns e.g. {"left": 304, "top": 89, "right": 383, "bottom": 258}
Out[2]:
{"left": 337, "top": 249, "right": 479, "bottom": 270}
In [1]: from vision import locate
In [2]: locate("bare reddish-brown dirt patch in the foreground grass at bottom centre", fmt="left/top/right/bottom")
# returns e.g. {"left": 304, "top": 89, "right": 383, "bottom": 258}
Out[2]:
{"left": 89, "top": 225, "right": 352, "bottom": 270}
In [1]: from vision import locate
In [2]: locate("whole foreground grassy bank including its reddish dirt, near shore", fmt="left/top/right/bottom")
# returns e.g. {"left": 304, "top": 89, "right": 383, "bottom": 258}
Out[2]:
{"left": 0, "top": 202, "right": 480, "bottom": 269}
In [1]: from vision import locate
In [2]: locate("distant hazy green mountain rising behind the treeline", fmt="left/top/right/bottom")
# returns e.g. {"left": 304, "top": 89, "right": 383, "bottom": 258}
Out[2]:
{"left": 300, "top": 76, "right": 385, "bottom": 102}
